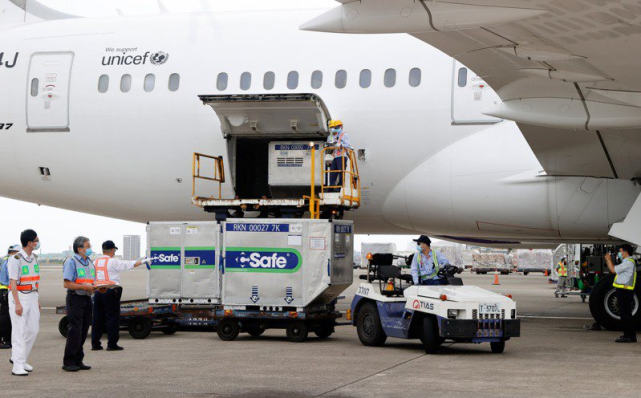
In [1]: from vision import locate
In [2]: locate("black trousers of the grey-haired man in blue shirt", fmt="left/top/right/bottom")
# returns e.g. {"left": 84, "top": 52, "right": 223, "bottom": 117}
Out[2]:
{"left": 63, "top": 292, "right": 93, "bottom": 366}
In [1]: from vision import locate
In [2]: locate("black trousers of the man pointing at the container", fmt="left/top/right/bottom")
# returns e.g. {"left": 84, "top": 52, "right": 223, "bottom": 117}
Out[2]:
{"left": 91, "top": 287, "right": 122, "bottom": 347}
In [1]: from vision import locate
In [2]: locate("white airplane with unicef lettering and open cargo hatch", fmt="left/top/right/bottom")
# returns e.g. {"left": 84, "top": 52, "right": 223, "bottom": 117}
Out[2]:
{"left": 0, "top": 0, "right": 641, "bottom": 246}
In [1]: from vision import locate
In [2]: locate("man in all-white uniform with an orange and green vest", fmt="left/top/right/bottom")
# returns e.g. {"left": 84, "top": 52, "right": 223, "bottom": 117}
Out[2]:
{"left": 7, "top": 229, "right": 40, "bottom": 376}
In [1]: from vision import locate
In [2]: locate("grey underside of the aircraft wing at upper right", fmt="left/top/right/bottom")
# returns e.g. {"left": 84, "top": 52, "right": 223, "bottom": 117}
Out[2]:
{"left": 301, "top": 0, "right": 641, "bottom": 179}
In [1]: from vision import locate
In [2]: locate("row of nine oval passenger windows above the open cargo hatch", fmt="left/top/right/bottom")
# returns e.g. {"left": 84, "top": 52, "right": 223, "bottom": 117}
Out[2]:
{"left": 216, "top": 68, "right": 422, "bottom": 91}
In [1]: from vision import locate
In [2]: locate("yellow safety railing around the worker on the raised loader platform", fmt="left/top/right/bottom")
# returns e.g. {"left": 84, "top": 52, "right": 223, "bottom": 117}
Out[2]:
{"left": 305, "top": 143, "right": 361, "bottom": 219}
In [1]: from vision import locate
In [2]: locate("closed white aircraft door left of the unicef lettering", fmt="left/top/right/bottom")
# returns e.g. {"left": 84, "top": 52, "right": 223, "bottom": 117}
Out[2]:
{"left": 27, "top": 52, "right": 74, "bottom": 132}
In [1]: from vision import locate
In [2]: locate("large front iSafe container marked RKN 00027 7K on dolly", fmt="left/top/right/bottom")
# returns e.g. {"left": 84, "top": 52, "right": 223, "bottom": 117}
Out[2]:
{"left": 222, "top": 219, "right": 354, "bottom": 310}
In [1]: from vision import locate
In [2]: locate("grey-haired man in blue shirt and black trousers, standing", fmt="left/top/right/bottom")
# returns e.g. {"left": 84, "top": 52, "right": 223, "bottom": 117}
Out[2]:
{"left": 62, "top": 236, "right": 96, "bottom": 372}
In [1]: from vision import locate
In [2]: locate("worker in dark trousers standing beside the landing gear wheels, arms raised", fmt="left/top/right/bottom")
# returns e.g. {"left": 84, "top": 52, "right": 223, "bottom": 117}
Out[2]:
{"left": 605, "top": 244, "right": 637, "bottom": 343}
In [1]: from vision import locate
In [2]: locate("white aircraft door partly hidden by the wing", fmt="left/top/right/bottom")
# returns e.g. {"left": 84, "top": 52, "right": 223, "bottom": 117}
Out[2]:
{"left": 452, "top": 60, "right": 501, "bottom": 124}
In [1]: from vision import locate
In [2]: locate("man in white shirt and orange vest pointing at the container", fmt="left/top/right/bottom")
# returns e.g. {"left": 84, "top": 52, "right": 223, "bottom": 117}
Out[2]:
{"left": 91, "top": 240, "right": 151, "bottom": 351}
